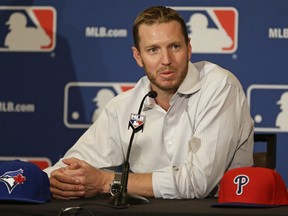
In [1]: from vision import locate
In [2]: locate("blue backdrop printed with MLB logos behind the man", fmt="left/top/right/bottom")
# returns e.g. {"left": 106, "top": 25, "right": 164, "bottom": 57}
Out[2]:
{"left": 0, "top": 0, "right": 288, "bottom": 184}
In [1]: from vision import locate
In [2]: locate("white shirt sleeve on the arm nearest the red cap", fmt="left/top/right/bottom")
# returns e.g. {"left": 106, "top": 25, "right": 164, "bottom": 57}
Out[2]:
{"left": 152, "top": 70, "right": 253, "bottom": 199}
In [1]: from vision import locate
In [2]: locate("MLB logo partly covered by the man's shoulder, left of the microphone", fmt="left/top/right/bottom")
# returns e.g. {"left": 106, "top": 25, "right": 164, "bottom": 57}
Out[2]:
{"left": 64, "top": 82, "right": 135, "bottom": 128}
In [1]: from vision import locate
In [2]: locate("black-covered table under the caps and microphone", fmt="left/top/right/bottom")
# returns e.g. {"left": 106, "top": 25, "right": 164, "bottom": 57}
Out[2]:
{"left": 0, "top": 195, "right": 288, "bottom": 216}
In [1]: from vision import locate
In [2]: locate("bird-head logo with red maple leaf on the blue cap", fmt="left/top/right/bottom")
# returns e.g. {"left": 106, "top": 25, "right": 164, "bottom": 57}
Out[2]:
{"left": 0, "top": 169, "right": 26, "bottom": 194}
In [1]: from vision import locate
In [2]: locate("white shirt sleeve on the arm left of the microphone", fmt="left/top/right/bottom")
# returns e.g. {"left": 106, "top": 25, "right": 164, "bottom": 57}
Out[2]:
{"left": 44, "top": 102, "right": 124, "bottom": 176}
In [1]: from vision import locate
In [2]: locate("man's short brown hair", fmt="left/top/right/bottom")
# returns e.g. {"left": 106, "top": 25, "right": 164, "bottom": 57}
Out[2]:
{"left": 133, "top": 6, "right": 188, "bottom": 50}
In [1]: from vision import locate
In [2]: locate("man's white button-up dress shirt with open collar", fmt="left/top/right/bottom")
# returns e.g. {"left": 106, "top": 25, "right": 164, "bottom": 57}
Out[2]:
{"left": 45, "top": 62, "right": 253, "bottom": 199}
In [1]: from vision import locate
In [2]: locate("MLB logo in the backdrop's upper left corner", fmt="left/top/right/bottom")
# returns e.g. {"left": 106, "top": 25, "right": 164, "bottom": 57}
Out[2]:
{"left": 0, "top": 6, "right": 56, "bottom": 52}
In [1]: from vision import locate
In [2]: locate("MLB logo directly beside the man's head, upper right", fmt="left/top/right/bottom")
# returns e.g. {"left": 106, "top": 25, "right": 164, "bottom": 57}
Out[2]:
{"left": 172, "top": 7, "right": 238, "bottom": 54}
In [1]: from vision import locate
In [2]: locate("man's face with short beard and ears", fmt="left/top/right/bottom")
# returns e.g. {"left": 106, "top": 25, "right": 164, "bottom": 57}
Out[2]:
{"left": 132, "top": 21, "right": 191, "bottom": 93}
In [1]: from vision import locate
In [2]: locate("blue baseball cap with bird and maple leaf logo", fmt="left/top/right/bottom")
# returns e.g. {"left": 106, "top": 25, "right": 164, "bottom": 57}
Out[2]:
{"left": 0, "top": 160, "right": 51, "bottom": 203}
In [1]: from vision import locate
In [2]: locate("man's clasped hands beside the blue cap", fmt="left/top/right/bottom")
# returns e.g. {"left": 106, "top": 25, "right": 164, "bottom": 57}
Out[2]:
{"left": 50, "top": 158, "right": 113, "bottom": 199}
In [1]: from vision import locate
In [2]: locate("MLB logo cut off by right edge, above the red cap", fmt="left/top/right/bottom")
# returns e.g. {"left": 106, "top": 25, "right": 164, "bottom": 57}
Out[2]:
{"left": 247, "top": 85, "right": 288, "bottom": 133}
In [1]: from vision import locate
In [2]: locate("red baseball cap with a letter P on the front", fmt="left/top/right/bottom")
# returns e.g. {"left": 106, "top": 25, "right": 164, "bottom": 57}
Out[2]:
{"left": 212, "top": 167, "right": 288, "bottom": 207}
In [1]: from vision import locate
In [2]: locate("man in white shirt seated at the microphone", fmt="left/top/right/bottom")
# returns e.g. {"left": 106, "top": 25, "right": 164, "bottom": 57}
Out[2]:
{"left": 45, "top": 7, "right": 253, "bottom": 199}
